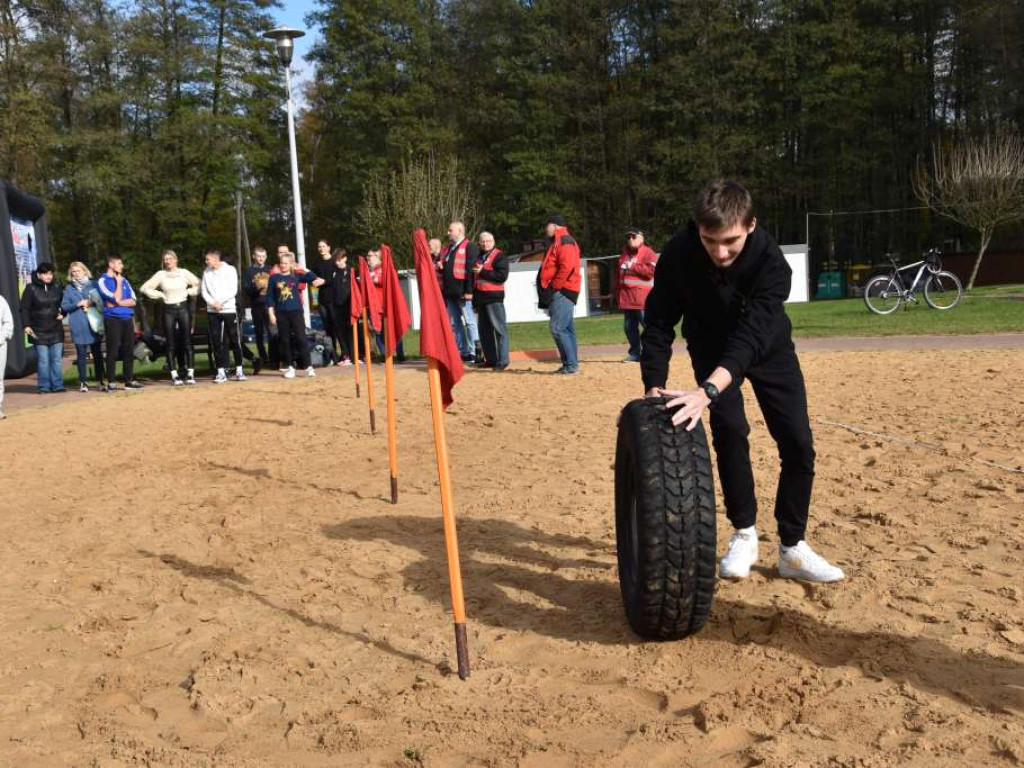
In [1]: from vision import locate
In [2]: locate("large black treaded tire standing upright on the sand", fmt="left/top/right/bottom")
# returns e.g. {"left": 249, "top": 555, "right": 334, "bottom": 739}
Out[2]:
{"left": 615, "top": 397, "right": 716, "bottom": 640}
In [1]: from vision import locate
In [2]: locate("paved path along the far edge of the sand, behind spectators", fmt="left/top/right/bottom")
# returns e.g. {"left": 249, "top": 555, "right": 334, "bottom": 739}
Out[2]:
{"left": 4, "top": 333, "right": 1024, "bottom": 414}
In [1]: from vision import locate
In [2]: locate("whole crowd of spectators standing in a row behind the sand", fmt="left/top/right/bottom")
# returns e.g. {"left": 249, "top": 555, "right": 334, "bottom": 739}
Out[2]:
{"left": 0, "top": 215, "right": 656, "bottom": 418}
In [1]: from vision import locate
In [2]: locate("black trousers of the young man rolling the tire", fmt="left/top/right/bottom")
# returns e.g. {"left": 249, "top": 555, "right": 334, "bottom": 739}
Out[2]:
{"left": 693, "top": 346, "right": 814, "bottom": 547}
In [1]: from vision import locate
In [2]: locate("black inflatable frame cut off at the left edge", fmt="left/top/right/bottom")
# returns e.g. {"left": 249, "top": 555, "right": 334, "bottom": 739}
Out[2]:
{"left": 0, "top": 179, "right": 53, "bottom": 379}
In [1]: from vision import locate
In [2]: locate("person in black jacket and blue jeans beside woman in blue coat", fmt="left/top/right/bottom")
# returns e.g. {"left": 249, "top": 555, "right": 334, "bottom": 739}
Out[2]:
{"left": 22, "top": 261, "right": 65, "bottom": 394}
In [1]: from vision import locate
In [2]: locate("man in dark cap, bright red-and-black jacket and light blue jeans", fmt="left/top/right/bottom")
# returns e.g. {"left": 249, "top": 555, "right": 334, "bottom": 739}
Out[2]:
{"left": 537, "top": 214, "right": 583, "bottom": 375}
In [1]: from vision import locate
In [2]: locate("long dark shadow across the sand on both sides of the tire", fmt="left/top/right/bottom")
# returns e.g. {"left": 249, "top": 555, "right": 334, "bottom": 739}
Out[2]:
{"left": 324, "top": 515, "right": 1024, "bottom": 715}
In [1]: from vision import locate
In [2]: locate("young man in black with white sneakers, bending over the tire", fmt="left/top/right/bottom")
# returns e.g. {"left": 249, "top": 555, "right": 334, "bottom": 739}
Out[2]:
{"left": 641, "top": 181, "right": 843, "bottom": 582}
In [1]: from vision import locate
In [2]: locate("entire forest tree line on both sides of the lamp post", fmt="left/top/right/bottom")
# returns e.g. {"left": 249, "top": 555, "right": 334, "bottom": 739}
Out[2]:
{"left": 0, "top": 0, "right": 1024, "bottom": 276}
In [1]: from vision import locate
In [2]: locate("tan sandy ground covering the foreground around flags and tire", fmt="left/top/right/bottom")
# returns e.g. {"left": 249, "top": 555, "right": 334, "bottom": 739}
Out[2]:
{"left": 0, "top": 349, "right": 1024, "bottom": 768}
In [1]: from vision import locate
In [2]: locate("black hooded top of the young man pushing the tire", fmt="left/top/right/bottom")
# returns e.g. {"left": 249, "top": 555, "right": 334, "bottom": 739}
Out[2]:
{"left": 640, "top": 222, "right": 793, "bottom": 389}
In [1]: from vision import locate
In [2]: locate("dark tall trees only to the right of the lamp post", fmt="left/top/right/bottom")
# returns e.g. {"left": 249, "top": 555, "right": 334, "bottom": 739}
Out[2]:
{"left": 307, "top": 0, "right": 1024, "bottom": 268}
